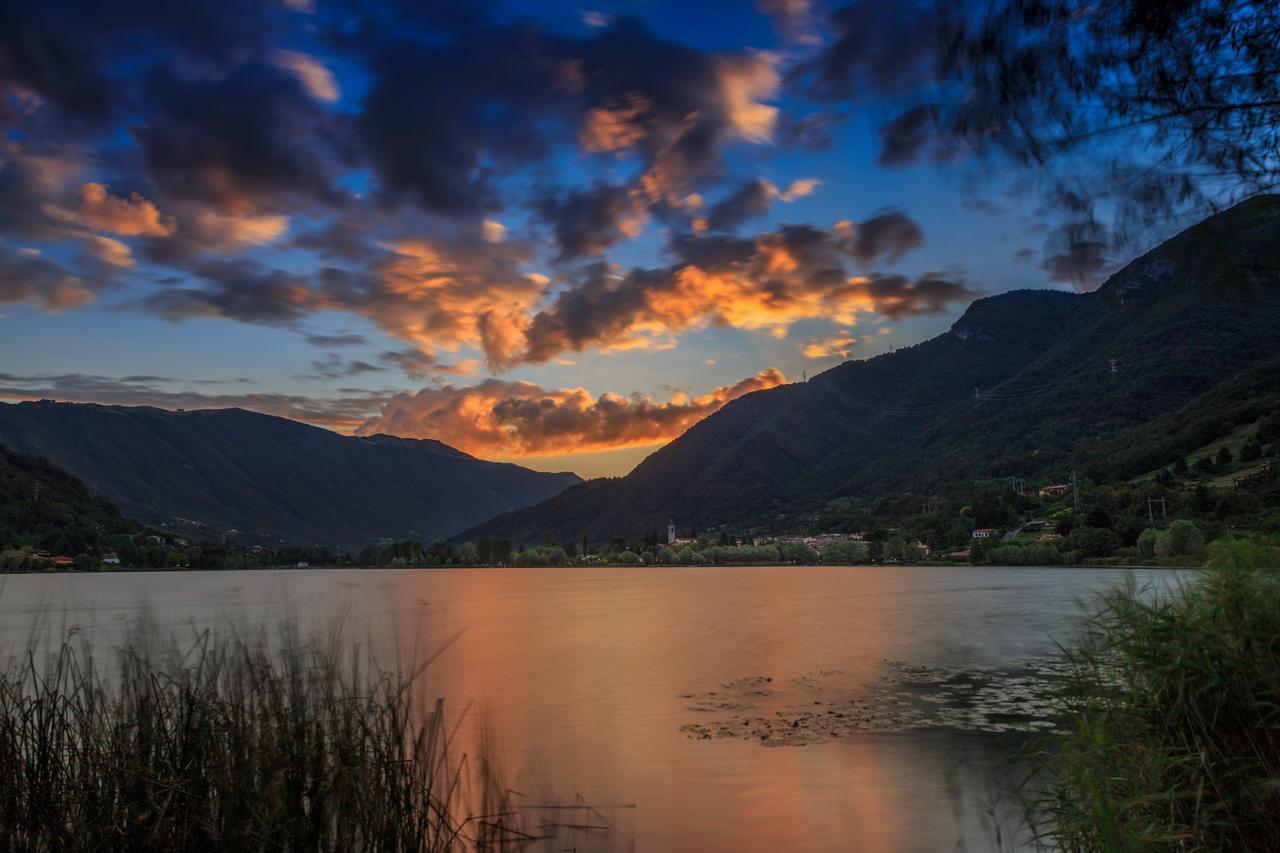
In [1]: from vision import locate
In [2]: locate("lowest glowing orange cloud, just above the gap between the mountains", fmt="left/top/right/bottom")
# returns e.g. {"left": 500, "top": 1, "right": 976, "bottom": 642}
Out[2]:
{"left": 357, "top": 368, "right": 786, "bottom": 456}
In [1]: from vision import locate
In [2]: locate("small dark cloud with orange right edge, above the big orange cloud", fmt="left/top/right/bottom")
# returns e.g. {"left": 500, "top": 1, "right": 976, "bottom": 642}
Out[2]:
{"left": 536, "top": 184, "right": 648, "bottom": 260}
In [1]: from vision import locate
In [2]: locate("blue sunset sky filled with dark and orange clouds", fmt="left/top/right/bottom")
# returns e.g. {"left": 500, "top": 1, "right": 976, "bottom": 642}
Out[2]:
{"left": 0, "top": 0, "right": 1073, "bottom": 476}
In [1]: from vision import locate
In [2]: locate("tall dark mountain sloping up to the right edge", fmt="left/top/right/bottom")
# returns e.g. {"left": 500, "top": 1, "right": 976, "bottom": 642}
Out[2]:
{"left": 458, "top": 196, "right": 1280, "bottom": 542}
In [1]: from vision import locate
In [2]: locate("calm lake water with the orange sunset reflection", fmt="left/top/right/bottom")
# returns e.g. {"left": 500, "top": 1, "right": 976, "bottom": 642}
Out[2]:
{"left": 0, "top": 567, "right": 1178, "bottom": 852}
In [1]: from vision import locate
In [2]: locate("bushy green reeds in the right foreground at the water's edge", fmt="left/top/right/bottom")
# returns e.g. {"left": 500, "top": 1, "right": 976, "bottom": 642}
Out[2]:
{"left": 1032, "top": 542, "right": 1280, "bottom": 852}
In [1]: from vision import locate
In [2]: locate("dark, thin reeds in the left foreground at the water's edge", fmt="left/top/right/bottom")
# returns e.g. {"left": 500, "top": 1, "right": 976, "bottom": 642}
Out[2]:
{"left": 0, "top": 614, "right": 530, "bottom": 852}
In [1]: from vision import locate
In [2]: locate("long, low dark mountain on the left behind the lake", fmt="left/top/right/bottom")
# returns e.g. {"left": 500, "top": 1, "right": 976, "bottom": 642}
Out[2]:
{"left": 0, "top": 401, "right": 580, "bottom": 549}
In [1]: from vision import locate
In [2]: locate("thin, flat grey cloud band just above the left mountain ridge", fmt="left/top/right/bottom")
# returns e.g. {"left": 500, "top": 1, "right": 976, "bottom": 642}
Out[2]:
{"left": 0, "top": 373, "right": 389, "bottom": 432}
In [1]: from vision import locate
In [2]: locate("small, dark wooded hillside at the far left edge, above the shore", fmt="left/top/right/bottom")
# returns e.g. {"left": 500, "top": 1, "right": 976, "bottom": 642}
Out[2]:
{"left": 0, "top": 446, "right": 142, "bottom": 555}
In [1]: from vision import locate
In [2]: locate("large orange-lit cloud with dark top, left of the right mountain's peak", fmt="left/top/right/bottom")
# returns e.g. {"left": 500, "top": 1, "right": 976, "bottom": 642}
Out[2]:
{"left": 509, "top": 211, "right": 952, "bottom": 366}
